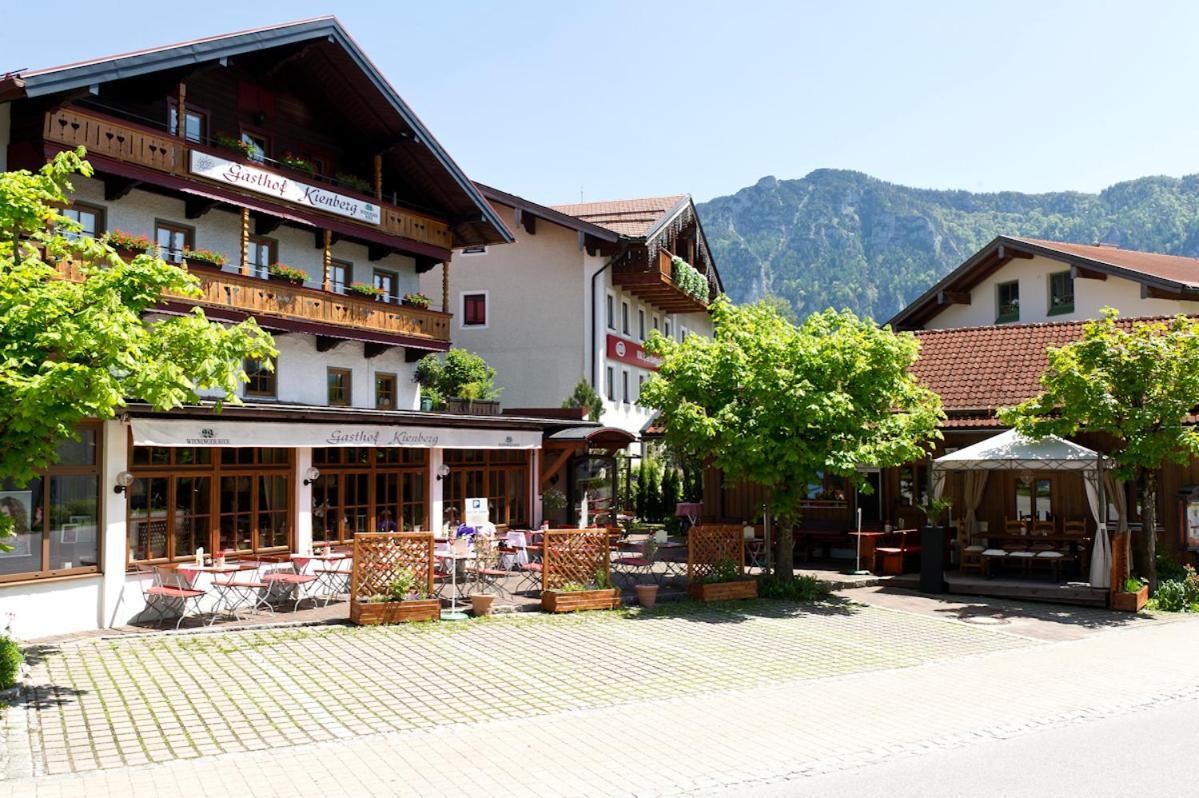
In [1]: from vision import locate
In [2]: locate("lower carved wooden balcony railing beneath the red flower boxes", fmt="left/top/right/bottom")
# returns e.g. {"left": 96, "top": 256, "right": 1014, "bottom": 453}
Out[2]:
{"left": 59, "top": 264, "right": 451, "bottom": 350}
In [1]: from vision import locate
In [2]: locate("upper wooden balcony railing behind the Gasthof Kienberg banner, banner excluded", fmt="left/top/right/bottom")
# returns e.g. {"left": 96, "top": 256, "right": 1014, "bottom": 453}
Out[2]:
{"left": 43, "top": 108, "right": 453, "bottom": 250}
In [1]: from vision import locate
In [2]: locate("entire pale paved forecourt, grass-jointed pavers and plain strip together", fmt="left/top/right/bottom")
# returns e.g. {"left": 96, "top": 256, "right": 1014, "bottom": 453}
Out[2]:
{"left": 0, "top": 588, "right": 1199, "bottom": 794}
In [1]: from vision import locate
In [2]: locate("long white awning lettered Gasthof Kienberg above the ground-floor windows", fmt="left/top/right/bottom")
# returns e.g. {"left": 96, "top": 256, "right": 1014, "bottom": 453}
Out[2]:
{"left": 131, "top": 418, "right": 541, "bottom": 449}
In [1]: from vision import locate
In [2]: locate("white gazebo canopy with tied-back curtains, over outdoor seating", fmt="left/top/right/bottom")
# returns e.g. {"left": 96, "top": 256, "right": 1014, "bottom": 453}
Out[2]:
{"left": 933, "top": 430, "right": 1119, "bottom": 587}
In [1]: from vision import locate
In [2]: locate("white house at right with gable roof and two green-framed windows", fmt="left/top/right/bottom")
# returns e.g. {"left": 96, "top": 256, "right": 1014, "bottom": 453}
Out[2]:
{"left": 890, "top": 236, "right": 1199, "bottom": 330}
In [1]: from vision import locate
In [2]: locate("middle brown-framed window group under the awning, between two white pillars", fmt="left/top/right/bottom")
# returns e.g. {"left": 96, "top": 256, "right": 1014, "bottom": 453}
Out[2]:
{"left": 312, "top": 447, "right": 429, "bottom": 536}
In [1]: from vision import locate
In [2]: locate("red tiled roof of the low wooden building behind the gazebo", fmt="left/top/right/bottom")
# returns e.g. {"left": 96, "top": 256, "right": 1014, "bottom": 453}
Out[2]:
{"left": 911, "top": 318, "right": 1184, "bottom": 412}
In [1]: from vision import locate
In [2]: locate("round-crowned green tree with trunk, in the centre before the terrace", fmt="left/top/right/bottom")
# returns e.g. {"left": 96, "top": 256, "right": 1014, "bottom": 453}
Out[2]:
{"left": 641, "top": 298, "right": 944, "bottom": 579}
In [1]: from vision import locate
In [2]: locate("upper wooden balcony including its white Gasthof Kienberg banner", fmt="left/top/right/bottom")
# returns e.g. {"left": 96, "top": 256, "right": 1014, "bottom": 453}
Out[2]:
{"left": 43, "top": 107, "right": 453, "bottom": 255}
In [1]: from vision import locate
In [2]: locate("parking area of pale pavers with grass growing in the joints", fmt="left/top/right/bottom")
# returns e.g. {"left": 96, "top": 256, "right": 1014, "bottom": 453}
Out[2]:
{"left": 2, "top": 600, "right": 1031, "bottom": 773}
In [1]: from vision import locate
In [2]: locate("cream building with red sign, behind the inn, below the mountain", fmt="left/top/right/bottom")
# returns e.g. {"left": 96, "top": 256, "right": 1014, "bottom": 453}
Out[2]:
{"left": 421, "top": 186, "right": 723, "bottom": 435}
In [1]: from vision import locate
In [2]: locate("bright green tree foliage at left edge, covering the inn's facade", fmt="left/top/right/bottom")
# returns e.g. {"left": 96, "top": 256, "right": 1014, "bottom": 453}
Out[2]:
{"left": 0, "top": 147, "right": 276, "bottom": 541}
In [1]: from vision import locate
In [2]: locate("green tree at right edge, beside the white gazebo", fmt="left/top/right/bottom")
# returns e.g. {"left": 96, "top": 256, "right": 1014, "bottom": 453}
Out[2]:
{"left": 999, "top": 308, "right": 1199, "bottom": 590}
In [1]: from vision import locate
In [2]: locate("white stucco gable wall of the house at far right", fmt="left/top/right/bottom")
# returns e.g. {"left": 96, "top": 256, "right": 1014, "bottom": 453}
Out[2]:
{"left": 924, "top": 255, "right": 1199, "bottom": 330}
